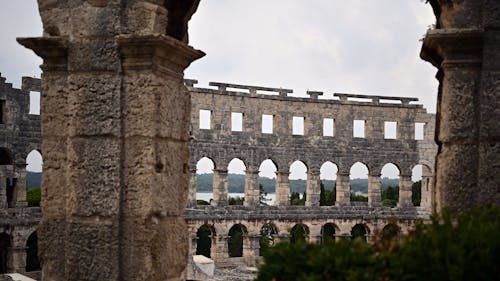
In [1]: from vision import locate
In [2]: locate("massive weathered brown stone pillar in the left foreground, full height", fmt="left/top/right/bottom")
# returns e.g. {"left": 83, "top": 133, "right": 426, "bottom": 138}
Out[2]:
{"left": 18, "top": 0, "right": 203, "bottom": 281}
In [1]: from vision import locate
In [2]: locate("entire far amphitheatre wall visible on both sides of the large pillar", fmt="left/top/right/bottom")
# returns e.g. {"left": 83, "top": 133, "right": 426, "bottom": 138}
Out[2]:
{"left": 0, "top": 71, "right": 437, "bottom": 276}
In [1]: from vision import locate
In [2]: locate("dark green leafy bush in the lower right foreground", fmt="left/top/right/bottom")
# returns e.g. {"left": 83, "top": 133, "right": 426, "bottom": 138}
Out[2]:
{"left": 256, "top": 203, "right": 500, "bottom": 281}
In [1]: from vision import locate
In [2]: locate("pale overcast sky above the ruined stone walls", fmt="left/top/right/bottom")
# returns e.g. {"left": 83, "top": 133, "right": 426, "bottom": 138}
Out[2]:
{"left": 0, "top": 0, "right": 437, "bottom": 179}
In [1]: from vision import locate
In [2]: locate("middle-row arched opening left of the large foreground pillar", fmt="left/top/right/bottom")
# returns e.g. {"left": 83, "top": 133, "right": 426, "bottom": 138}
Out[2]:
{"left": 26, "top": 149, "right": 43, "bottom": 207}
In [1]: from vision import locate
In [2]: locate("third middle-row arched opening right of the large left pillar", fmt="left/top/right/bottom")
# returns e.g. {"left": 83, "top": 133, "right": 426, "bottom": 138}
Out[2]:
{"left": 259, "top": 159, "right": 278, "bottom": 205}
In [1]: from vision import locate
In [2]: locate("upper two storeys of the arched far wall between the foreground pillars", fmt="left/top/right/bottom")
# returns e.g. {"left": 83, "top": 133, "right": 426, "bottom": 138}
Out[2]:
{"left": 187, "top": 80, "right": 436, "bottom": 210}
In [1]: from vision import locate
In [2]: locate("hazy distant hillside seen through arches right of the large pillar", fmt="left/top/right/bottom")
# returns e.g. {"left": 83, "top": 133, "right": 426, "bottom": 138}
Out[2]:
{"left": 196, "top": 174, "right": 399, "bottom": 193}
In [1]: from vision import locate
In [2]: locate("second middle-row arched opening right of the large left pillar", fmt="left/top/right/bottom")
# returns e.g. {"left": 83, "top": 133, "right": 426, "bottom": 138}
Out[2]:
{"left": 227, "top": 158, "right": 246, "bottom": 205}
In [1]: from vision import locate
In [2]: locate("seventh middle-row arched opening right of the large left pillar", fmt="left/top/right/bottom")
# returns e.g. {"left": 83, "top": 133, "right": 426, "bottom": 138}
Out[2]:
{"left": 380, "top": 163, "right": 399, "bottom": 208}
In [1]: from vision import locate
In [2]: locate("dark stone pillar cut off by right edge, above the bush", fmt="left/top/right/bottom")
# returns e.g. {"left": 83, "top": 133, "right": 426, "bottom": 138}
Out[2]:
{"left": 421, "top": 0, "right": 500, "bottom": 211}
